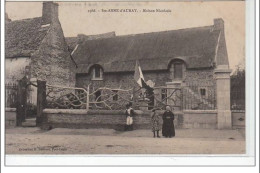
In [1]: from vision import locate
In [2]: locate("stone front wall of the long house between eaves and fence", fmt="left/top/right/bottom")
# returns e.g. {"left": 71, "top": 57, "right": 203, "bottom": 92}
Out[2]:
{"left": 76, "top": 69, "right": 214, "bottom": 89}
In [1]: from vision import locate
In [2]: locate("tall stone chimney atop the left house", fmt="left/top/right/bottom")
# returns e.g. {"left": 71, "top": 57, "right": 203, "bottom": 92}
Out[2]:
{"left": 42, "top": 1, "right": 59, "bottom": 25}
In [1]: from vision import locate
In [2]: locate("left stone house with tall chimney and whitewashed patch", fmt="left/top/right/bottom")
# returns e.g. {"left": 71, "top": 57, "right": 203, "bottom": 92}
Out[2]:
{"left": 5, "top": 2, "right": 76, "bottom": 86}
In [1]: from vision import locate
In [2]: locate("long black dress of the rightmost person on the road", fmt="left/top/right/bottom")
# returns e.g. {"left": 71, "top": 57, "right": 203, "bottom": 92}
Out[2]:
{"left": 162, "top": 111, "right": 175, "bottom": 137}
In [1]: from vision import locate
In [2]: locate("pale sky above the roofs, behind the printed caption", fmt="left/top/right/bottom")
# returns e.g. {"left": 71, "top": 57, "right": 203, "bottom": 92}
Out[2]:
{"left": 6, "top": 1, "right": 245, "bottom": 70}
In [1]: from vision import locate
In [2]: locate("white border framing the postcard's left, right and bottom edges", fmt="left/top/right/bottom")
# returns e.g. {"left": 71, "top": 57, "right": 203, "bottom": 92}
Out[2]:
{"left": 1, "top": 0, "right": 259, "bottom": 168}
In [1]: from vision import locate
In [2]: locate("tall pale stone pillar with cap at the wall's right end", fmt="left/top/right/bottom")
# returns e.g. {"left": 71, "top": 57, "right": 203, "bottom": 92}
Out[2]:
{"left": 214, "top": 67, "right": 232, "bottom": 129}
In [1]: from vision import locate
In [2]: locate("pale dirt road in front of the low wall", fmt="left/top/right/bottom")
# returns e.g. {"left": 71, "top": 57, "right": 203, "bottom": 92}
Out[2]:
{"left": 6, "top": 127, "right": 245, "bottom": 154}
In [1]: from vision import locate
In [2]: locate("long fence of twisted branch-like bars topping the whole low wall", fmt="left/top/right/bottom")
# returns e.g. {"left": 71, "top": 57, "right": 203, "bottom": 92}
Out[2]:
{"left": 46, "top": 83, "right": 216, "bottom": 110}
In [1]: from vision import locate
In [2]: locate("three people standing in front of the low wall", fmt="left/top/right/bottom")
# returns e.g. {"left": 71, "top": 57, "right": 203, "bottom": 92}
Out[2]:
{"left": 125, "top": 104, "right": 175, "bottom": 138}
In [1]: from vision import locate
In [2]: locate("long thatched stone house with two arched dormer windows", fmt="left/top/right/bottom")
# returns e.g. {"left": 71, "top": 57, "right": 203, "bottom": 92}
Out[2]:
{"left": 72, "top": 19, "right": 229, "bottom": 112}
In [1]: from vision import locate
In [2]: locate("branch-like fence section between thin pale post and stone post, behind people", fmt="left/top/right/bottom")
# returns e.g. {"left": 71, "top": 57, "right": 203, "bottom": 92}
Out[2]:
{"left": 86, "top": 87, "right": 182, "bottom": 110}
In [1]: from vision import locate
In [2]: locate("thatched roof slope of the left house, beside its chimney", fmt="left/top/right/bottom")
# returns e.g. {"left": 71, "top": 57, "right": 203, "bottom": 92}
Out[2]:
{"left": 5, "top": 17, "right": 49, "bottom": 58}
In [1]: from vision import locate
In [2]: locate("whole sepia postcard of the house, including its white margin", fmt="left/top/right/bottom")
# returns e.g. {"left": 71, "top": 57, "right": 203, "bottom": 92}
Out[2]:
{"left": 2, "top": 1, "right": 255, "bottom": 166}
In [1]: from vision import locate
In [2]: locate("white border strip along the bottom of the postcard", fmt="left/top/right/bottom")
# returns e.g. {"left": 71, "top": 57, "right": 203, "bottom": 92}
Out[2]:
{"left": 3, "top": 155, "right": 254, "bottom": 166}
